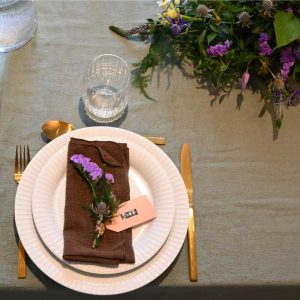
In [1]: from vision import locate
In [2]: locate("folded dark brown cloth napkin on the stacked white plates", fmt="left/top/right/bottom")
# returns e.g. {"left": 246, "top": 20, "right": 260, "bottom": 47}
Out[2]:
{"left": 63, "top": 138, "right": 134, "bottom": 264}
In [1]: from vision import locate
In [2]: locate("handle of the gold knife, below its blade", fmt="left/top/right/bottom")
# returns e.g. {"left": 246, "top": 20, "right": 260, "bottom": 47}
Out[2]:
{"left": 188, "top": 207, "right": 198, "bottom": 281}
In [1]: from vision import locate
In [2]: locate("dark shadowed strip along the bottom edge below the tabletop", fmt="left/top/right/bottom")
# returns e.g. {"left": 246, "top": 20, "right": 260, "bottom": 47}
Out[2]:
{"left": 0, "top": 286, "right": 300, "bottom": 300}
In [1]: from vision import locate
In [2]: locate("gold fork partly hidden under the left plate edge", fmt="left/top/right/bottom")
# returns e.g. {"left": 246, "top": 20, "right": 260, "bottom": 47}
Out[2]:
{"left": 15, "top": 145, "right": 30, "bottom": 278}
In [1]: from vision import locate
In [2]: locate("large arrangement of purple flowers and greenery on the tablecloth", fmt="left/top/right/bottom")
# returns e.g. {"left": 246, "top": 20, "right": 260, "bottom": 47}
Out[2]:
{"left": 110, "top": 0, "right": 300, "bottom": 130}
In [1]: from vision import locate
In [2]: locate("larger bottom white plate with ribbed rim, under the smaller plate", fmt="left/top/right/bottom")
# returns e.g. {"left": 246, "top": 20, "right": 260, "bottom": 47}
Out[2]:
{"left": 15, "top": 127, "right": 188, "bottom": 295}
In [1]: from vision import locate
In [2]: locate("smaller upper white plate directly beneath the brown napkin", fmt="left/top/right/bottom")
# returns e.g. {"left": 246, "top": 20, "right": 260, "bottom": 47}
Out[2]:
{"left": 32, "top": 136, "right": 175, "bottom": 274}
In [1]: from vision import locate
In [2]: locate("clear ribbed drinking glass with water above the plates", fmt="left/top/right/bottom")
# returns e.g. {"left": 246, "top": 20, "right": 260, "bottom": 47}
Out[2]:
{"left": 82, "top": 54, "right": 131, "bottom": 123}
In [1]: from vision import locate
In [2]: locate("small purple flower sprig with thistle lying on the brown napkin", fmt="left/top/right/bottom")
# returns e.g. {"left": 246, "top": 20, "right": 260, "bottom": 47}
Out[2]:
{"left": 70, "top": 154, "right": 120, "bottom": 248}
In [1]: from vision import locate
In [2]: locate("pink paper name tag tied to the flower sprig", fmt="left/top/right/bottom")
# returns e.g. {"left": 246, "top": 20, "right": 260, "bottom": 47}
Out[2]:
{"left": 105, "top": 195, "right": 156, "bottom": 232}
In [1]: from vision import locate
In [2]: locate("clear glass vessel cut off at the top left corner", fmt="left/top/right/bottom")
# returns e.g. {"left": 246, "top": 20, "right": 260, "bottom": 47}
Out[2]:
{"left": 0, "top": 0, "right": 37, "bottom": 52}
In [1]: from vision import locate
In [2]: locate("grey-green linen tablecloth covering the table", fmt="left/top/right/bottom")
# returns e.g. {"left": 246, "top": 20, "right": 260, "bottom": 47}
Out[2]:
{"left": 0, "top": 0, "right": 300, "bottom": 293}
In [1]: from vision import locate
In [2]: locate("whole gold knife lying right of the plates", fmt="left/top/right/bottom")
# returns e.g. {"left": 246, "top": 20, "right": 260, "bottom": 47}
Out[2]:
{"left": 181, "top": 144, "right": 198, "bottom": 281}
